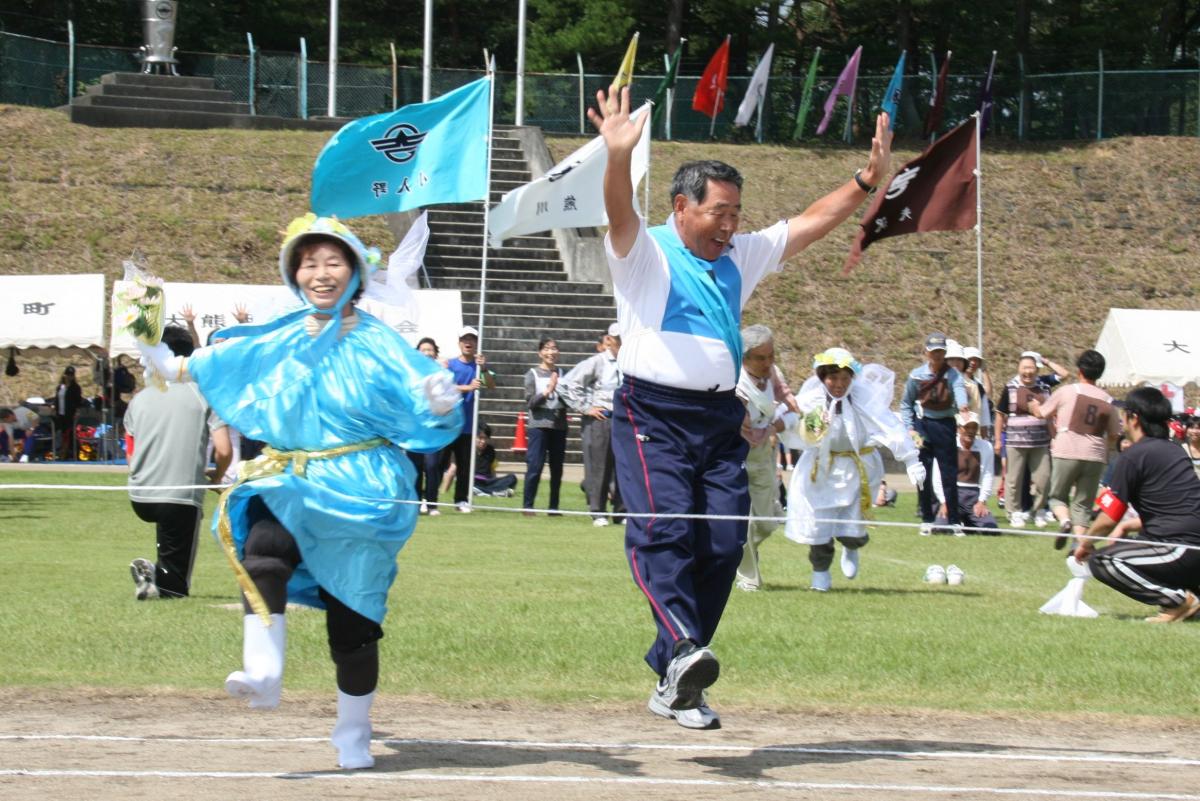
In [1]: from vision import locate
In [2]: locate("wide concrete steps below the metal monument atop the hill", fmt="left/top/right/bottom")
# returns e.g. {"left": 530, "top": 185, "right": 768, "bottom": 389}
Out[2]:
{"left": 67, "top": 72, "right": 346, "bottom": 131}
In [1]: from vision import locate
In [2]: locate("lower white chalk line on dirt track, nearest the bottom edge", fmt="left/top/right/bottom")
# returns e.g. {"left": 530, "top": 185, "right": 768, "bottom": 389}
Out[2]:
{"left": 0, "top": 770, "right": 1200, "bottom": 801}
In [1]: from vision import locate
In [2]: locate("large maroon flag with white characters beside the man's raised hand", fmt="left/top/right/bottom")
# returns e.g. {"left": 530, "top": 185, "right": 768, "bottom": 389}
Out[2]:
{"left": 845, "top": 118, "right": 977, "bottom": 272}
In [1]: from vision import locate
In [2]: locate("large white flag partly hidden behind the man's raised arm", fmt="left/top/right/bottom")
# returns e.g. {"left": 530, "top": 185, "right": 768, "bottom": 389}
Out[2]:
{"left": 487, "top": 103, "right": 650, "bottom": 247}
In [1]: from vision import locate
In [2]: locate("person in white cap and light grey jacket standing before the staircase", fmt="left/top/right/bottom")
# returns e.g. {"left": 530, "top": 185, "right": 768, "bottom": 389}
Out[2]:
{"left": 558, "top": 323, "right": 625, "bottom": 528}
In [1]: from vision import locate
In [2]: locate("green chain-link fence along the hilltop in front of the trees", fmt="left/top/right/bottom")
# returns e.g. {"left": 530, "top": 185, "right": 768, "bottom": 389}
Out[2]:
{"left": 0, "top": 31, "right": 1200, "bottom": 141}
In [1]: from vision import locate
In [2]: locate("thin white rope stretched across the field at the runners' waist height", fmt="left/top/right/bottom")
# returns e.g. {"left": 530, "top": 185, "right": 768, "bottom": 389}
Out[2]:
{"left": 0, "top": 483, "right": 1200, "bottom": 550}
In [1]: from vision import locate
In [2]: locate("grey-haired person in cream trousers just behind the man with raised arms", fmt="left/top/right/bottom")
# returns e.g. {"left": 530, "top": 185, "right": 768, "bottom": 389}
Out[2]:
{"left": 734, "top": 325, "right": 800, "bottom": 592}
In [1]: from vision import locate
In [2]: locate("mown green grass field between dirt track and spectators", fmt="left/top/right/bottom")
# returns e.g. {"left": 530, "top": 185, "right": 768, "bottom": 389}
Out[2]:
{"left": 0, "top": 462, "right": 1200, "bottom": 722}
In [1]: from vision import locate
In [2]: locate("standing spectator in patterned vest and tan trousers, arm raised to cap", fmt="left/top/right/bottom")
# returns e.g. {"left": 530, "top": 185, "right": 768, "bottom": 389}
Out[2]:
{"left": 995, "top": 350, "right": 1067, "bottom": 529}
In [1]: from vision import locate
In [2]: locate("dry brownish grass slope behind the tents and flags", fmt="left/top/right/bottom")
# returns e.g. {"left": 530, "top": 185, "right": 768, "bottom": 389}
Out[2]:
{"left": 0, "top": 106, "right": 1200, "bottom": 402}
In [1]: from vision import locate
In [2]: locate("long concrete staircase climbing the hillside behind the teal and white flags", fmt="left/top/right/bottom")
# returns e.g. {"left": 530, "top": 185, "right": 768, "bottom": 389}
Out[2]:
{"left": 425, "top": 127, "right": 617, "bottom": 462}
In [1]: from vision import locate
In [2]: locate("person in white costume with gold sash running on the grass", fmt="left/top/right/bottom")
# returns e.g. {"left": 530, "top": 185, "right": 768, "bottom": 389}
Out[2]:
{"left": 780, "top": 348, "right": 925, "bottom": 592}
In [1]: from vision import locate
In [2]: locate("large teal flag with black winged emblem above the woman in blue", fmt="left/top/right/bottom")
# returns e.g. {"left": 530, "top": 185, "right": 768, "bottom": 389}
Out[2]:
{"left": 312, "top": 78, "right": 491, "bottom": 219}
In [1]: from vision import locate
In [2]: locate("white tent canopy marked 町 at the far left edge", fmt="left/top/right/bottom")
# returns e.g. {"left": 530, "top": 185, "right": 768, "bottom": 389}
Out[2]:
{"left": 0, "top": 275, "right": 104, "bottom": 349}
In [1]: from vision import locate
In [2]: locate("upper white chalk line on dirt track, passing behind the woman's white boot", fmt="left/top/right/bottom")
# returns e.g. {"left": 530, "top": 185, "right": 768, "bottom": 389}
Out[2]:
{"left": 0, "top": 734, "right": 1200, "bottom": 767}
